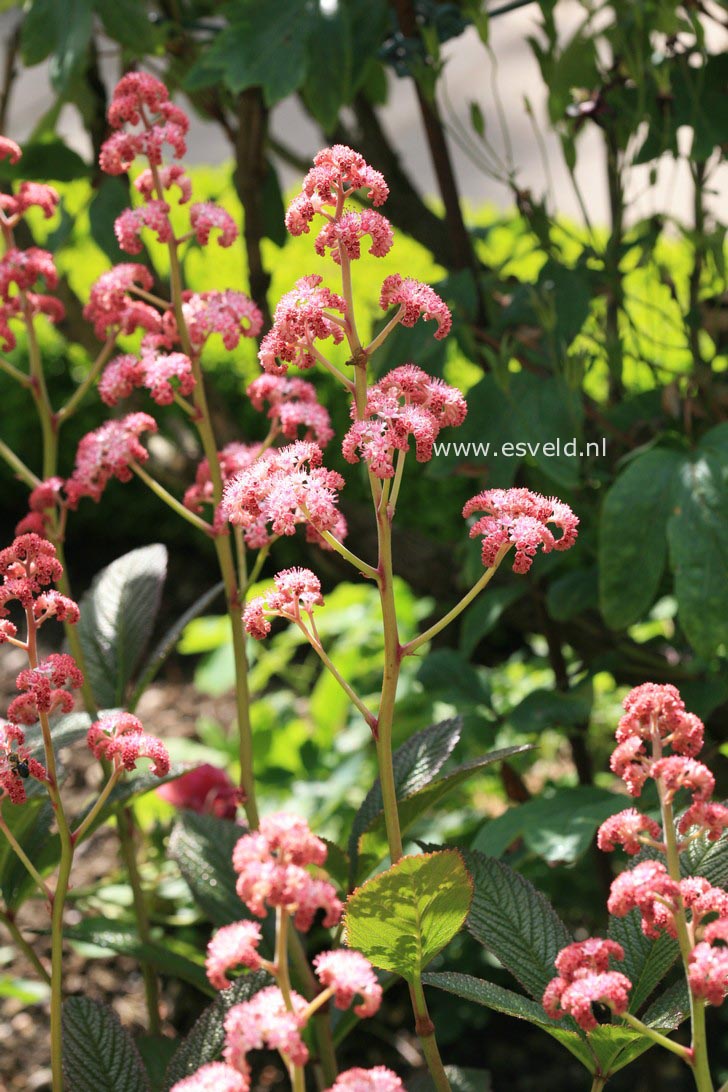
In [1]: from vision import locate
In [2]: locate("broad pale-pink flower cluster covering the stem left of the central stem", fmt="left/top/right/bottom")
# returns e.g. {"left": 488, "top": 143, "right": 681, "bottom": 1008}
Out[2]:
{"left": 220, "top": 440, "right": 346, "bottom": 548}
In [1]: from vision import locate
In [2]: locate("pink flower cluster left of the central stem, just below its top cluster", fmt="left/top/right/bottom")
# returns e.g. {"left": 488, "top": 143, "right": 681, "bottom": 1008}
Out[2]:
{"left": 258, "top": 273, "right": 346, "bottom": 376}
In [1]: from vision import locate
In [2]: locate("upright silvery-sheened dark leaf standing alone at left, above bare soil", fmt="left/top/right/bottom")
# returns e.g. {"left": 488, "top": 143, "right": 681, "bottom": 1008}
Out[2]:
{"left": 77, "top": 544, "right": 167, "bottom": 708}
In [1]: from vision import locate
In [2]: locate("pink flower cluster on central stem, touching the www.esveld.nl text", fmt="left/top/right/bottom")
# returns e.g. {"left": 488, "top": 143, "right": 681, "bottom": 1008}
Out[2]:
{"left": 342, "top": 364, "right": 467, "bottom": 478}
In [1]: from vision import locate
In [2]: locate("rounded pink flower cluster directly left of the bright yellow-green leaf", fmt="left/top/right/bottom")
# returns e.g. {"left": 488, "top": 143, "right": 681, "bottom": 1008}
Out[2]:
{"left": 232, "top": 812, "right": 343, "bottom": 931}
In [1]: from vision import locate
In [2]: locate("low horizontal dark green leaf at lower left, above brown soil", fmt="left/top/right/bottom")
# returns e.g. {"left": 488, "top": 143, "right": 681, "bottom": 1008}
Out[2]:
{"left": 64, "top": 917, "right": 214, "bottom": 995}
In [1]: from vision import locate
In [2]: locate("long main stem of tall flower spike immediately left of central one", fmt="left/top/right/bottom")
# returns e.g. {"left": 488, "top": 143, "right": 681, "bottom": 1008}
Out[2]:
{"left": 157, "top": 174, "right": 259, "bottom": 830}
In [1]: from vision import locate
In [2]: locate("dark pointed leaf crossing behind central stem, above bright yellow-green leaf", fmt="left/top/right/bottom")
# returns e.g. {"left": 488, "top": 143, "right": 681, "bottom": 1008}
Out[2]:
{"left": 348, "top": 716, "right": 463, "bottom": 880}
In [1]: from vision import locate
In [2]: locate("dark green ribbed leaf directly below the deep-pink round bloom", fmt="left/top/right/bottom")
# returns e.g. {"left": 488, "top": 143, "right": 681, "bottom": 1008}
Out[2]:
{"left": 169, "top": 811, "right": 248, "bottom": 925}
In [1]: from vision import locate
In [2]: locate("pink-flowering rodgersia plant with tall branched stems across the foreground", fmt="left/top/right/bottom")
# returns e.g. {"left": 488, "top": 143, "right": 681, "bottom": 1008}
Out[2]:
{"left": 0, "top": 66, "right": 728, "bottom": 1092}
